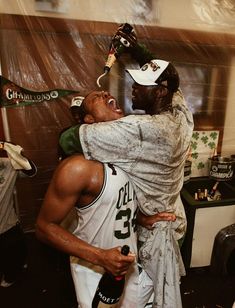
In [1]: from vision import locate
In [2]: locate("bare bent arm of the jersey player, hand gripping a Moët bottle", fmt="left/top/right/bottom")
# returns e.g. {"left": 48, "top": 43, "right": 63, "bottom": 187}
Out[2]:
{"left": 36, "top": 157, "right": 135, "bottom": 275}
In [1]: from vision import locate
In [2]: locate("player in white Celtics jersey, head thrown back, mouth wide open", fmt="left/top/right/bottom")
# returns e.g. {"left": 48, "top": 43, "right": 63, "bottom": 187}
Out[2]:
{"left": 36, "top": 96, "right": 174, "bottom": 308}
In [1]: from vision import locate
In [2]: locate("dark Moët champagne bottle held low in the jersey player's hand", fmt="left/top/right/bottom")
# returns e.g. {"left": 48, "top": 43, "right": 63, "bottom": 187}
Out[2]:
{"left": 92, "top": 245, "right": 130, "bottom": 308}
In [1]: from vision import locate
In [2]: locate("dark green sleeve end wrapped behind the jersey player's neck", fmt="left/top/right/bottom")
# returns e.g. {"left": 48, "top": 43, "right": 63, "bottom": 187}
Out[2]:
{"left": 59, "top": 124, "right": 83, "bottom": 156}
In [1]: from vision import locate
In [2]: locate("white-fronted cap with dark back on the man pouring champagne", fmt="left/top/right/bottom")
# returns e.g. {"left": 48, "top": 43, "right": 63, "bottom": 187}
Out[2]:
{"left": 126, "top": 59, "right": 179, "bottom": 91}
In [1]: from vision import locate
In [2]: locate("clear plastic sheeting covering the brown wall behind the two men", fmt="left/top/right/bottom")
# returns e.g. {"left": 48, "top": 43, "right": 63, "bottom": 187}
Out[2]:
{"left": 0, "top": 0, "right": 235, "bottom": 231}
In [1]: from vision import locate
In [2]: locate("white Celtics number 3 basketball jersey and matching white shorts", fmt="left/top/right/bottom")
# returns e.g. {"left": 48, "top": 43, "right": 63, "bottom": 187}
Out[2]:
{"left": 71, "top": 164, "right": 138, "bottom": 308}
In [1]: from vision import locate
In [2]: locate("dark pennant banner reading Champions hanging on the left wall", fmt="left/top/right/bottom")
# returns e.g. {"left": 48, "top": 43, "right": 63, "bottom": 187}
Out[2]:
{"left": 0, "top": 76, "right": 79, "bottom": 107}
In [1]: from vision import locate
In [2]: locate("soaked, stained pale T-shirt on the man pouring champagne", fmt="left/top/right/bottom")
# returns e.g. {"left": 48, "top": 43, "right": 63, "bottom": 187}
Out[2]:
{"left": 79, "top": 91, "right": 193, "bottom": 307}
